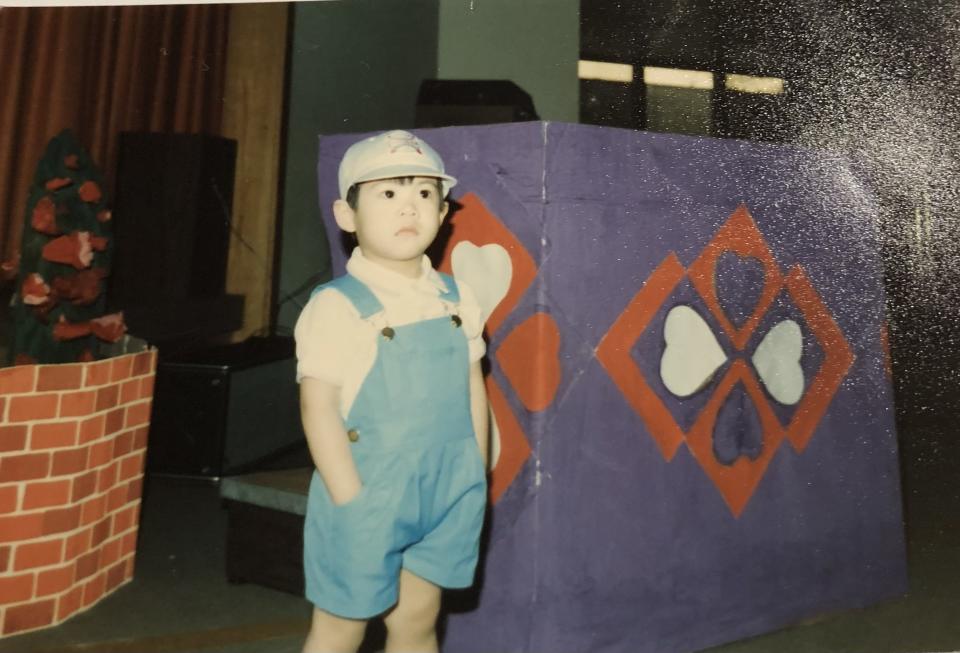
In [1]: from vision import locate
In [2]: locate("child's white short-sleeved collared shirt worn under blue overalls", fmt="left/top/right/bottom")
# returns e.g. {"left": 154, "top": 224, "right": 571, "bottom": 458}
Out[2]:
{"left": 294, "top": 247, "right": 486, "bottom": 418}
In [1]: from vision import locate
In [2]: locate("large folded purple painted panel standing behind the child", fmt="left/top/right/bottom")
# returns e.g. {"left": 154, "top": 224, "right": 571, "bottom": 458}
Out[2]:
{"left": 318, "top": 123, "right": 906, "bottom": 653}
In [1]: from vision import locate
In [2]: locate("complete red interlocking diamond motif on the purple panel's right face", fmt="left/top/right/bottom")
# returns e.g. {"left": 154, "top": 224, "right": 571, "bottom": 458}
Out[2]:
{"left": 596, "top": 206, "right": 854, "bottom": 516}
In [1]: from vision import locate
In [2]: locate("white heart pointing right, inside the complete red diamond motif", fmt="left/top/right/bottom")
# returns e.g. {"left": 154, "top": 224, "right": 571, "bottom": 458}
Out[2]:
{"left": 660, "top": 304, "right": 727, "bottom": 397}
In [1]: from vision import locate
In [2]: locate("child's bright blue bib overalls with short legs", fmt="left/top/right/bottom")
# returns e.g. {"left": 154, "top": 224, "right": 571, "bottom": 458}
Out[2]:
{"left": 303, "top": 274, "right": 487, "bottom": 619}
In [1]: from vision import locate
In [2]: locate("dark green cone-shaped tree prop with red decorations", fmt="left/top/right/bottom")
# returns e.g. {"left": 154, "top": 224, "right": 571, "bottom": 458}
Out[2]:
{"left": 12, "top": 130, "right": 126, "bottom": 365}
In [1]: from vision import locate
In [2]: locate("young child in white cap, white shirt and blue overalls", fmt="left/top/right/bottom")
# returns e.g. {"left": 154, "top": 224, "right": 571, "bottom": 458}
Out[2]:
{"left": 295, "top": 131, "right": 487, "bottom": 653}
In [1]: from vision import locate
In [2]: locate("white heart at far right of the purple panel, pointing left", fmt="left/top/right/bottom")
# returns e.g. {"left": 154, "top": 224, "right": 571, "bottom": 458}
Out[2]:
{"left": 751, "top": 320, "right": 804, "bottom": 406}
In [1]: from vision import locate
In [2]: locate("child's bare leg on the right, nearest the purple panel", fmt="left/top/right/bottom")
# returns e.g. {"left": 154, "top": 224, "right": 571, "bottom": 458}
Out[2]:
{"left": 383, "top": 569, "right": 440, "bottom": 653}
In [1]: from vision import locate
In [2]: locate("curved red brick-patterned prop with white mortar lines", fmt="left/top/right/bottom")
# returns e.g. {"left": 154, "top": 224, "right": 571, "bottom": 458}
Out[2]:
{"left": 0, "top": 350, "right": 157, "bottom": 637}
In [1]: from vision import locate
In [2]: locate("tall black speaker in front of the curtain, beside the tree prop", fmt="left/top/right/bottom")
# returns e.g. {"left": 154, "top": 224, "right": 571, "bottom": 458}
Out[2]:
{"left": 107, "top": 132, "right": 243, "bottom": 343}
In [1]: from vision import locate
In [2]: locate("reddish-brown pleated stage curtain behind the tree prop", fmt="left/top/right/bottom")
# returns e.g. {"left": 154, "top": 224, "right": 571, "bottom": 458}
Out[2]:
{"left": 0, "top": 5, "right": 229, "bottom": 262}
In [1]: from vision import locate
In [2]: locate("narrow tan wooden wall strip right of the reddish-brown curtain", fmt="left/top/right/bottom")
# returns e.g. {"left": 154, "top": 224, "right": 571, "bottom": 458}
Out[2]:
{"left": 223, "top": 3, "right": 289, "bottom": 341}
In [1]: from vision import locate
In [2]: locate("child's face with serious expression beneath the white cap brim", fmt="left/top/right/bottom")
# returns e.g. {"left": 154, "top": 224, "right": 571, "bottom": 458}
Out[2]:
{"left": 333, "top": 177, "right": 448, "bottom": 271}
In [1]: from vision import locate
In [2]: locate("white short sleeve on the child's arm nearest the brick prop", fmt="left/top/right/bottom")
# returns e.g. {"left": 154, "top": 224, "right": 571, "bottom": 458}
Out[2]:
{"left": 293, "top": 288, "right": 360, "bottom": 386}
